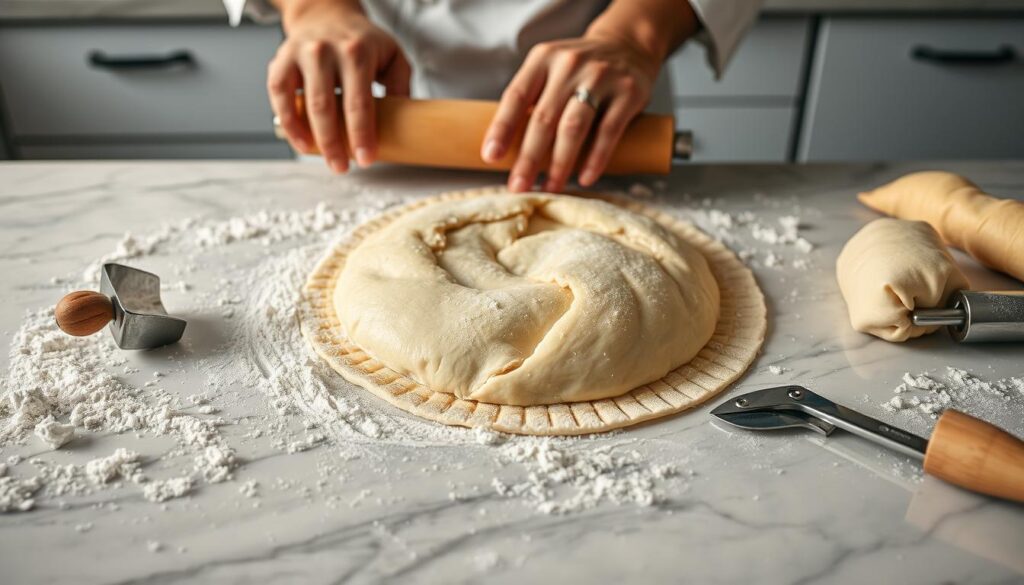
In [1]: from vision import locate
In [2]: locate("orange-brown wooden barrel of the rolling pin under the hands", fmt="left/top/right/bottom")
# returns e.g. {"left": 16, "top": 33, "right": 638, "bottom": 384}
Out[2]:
{"left": 296, "top": 95, "right": 675, "bottom": 174}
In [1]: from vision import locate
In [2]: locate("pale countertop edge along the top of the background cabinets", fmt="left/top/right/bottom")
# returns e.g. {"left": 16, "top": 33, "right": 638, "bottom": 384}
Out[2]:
{"left": 0, "top": 0, "right": 1024, "bottom": 22}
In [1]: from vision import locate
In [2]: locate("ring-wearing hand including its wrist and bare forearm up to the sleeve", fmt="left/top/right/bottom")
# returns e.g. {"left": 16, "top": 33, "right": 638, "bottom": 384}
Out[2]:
{"left": 480, "top": 0, "right": 697, "bottom": 193}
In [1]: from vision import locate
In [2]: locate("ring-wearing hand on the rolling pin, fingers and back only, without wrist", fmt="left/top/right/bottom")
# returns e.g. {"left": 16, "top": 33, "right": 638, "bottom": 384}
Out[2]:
{"left": 480, "top": 35, "right": 662, "bottom": 193}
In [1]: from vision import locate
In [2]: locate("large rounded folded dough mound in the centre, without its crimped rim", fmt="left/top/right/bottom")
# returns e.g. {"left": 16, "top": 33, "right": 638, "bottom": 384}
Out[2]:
{"left": 333, "top": 194, "right": 719, "bottom": 406}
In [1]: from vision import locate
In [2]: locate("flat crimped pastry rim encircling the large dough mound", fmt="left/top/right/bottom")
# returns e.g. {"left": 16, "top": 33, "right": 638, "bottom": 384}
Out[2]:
{"left": 300, "top": 190, "right": 767, "bottom": 435}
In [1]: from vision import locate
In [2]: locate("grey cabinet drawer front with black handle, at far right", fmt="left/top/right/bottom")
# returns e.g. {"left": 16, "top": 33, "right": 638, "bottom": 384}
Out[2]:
{"left": 800, "top": 18, "right": 1024, "bottom": 161}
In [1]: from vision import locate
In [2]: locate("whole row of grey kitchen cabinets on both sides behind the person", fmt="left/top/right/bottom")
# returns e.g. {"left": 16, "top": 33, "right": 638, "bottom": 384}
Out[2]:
{"left": 0, "top": 13, "right": 1024, "bottom": 162}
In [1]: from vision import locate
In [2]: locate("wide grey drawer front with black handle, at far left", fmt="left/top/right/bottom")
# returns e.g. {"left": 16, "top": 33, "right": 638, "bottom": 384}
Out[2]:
{"left": 0, "top": 24, "right": 280, "bottom": 138}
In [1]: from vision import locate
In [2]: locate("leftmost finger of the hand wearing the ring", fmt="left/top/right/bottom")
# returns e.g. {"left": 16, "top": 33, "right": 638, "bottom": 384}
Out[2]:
{"left": 480, "top": 49, "right": 547, "bottom": 163}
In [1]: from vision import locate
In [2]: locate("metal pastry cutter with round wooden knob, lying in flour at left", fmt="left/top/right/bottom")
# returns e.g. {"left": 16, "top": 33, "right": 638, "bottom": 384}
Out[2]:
{"left": 54, "top": 263, "right": 185, "bottom": 349}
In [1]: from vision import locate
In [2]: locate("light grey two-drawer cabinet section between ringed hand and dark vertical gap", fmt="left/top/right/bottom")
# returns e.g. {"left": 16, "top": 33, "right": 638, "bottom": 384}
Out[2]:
{"left": 668, "top": 16, "right": 811, "bottom": 162}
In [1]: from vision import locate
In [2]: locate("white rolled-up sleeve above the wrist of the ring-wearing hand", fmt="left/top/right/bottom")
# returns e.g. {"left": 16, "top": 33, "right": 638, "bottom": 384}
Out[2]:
{"left": 689, "top": 0, "right": 761, "bottom": 78}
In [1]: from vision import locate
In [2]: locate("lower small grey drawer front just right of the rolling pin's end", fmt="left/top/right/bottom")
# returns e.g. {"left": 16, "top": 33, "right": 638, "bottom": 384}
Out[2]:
{"left": 676, "top": 107, "right": 796, "bottom": 163}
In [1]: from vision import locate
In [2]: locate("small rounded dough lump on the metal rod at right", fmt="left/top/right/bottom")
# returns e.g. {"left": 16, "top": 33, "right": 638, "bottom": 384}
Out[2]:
{"left": 836, "top": 217, "right": 970, "bottom": 341}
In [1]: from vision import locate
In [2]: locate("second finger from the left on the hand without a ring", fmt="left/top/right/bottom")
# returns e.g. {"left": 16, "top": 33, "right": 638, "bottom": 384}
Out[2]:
{"left": 299, "top": 42, "right": 348, "bottom": 173}
